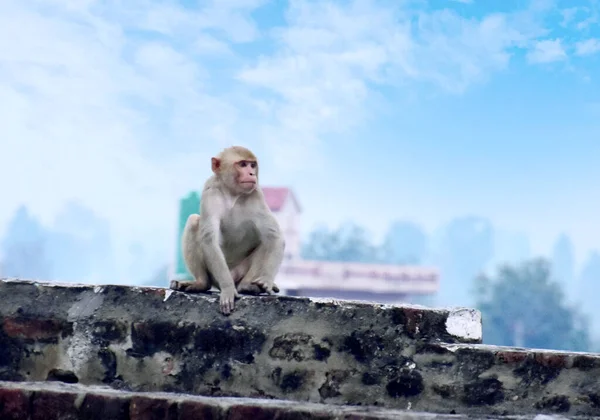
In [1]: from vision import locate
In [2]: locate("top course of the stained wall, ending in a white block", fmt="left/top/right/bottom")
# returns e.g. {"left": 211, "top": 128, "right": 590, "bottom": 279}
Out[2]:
{"left": 0, "top": 279, "right": 482, "bottom": 343}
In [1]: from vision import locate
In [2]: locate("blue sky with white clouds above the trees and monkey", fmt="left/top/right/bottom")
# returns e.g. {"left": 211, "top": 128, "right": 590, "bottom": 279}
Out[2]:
{"left": 0, "top": 0, "right": 600, "bottom": 278}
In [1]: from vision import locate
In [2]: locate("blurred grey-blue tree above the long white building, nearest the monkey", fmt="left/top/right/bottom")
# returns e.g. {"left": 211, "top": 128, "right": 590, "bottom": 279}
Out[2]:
{"left": 302, "top": 223, "right": 380, "bottom": 263}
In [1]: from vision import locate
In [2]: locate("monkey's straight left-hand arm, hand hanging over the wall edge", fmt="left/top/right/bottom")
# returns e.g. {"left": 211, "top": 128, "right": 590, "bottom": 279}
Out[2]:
{"left": 200, "top": 190, "right": 238, "bottom": 314}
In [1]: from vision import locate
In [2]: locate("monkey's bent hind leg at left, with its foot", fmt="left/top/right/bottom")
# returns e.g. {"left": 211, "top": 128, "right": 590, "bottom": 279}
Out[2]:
{"left": 170, "top": 214, "right": 212, "bottom": 293}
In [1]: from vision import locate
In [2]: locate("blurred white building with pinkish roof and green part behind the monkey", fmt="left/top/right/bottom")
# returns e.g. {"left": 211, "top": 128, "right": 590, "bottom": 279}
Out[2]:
{"left": 171, "top": 187, "right": 439, "bottom": 303}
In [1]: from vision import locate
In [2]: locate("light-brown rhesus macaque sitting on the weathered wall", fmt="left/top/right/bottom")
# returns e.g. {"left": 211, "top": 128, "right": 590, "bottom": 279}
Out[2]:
{"left": 171, "top": 146, "right": 285, "bottom": 315}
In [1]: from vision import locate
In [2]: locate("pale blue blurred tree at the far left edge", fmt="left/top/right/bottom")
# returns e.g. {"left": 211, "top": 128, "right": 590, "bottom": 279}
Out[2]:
{"left": 2, "top": 206, "right": 52, "bottom": 280}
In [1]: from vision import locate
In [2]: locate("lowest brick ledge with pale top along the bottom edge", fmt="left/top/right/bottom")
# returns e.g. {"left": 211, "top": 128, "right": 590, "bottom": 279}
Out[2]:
{"left": 0, "top": 382, "right": 591, "bottom": 420}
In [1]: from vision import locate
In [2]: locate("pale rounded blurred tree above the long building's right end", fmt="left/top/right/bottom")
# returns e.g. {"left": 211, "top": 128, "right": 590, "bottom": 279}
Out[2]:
{"left": 381, "top": 221, "right": 427, "bottom": 264}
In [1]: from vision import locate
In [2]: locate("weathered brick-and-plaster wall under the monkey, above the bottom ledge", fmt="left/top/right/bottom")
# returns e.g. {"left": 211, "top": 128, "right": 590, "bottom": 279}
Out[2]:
{"left": 0, "top": 281, "right": 600, "bottom": 415}
